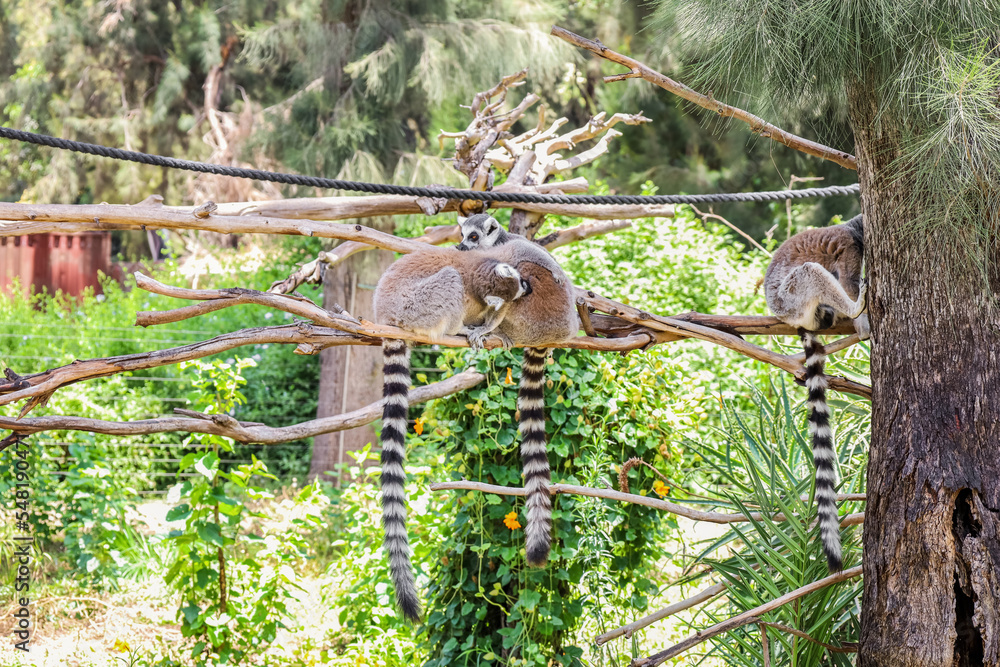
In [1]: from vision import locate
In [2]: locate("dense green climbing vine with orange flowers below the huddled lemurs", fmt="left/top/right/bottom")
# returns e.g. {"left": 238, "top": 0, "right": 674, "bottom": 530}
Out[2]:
{"left": 423, "top": 351, "right": 662, "bottom": 665}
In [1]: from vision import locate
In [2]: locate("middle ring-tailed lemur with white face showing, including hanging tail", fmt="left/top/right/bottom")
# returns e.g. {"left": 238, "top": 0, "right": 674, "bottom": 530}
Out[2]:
{"left": 456, "top": 213, "right": 580, "bottom": 566}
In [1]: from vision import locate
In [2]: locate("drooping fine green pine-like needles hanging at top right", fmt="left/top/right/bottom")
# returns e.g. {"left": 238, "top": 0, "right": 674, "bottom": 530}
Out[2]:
{"left": 656, "top": 0, "right": 1000, "bottom": 276}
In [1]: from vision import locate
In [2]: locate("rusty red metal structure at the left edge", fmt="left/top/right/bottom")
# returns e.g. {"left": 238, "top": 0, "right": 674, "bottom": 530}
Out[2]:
{"left": 0, "top": 232, "right": 111, "bottom": 296}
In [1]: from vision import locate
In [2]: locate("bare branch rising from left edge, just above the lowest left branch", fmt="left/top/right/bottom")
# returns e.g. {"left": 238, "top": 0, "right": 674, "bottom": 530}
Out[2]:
{"left": 0, "top": 322, "right": 374, "bottom": 405}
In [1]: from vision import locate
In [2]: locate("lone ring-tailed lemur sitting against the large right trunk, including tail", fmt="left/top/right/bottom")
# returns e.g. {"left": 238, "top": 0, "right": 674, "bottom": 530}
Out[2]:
{"left": 764, "top": 215, "right": 869, "bottom": 571}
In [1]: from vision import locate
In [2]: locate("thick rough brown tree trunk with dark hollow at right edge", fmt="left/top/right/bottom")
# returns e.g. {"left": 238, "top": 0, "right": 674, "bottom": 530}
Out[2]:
{"left": 849, "top": 82, "right": 1000, "bottom": 667}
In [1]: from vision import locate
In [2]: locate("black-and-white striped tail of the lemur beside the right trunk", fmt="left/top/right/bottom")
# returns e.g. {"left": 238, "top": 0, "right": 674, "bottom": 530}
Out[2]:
{"left": 799, "top": 330, "right": 843, "bottom": 572}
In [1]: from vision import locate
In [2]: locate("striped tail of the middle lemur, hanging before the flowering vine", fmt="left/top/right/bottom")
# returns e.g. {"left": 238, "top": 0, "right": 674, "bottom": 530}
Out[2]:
{"left": 517, "top": 347, "right": 552, "bottom": 567}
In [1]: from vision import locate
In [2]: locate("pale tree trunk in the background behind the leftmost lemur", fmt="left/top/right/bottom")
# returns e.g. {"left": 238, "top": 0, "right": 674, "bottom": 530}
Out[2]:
{"left": 309, "top": 225, "right": 393, "bottom": 479}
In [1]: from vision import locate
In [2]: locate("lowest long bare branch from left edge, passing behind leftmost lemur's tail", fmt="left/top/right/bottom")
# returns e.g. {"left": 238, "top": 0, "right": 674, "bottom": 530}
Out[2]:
{"left": 0, "top": 370, "right": 486, "bottom": 445}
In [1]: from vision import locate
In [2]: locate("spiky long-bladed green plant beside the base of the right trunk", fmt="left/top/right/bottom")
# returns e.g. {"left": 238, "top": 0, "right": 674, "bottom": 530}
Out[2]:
{"left": 688, "top": 382, "right": 871, "bottom": 666}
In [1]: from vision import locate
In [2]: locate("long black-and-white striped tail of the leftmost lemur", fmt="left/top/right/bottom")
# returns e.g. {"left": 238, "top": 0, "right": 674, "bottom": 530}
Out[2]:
{"left": 382, "top": 339, "right": 420, "bottom": 621}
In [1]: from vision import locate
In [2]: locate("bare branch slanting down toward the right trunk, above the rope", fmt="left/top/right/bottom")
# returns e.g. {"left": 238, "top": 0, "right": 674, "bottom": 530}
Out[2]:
{"left": 552, "top": 26, "right": 858, "bottom": 170}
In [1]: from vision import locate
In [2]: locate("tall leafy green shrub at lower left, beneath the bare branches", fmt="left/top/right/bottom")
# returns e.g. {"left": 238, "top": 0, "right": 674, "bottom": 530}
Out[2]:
{"left": 165, "top": 359, "right": 326, "bottom": 665}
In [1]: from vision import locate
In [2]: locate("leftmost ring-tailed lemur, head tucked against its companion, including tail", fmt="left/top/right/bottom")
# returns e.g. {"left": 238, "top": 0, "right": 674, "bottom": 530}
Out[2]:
{"left": 374, "top": 249, "right": 530, "bottom": 620}
